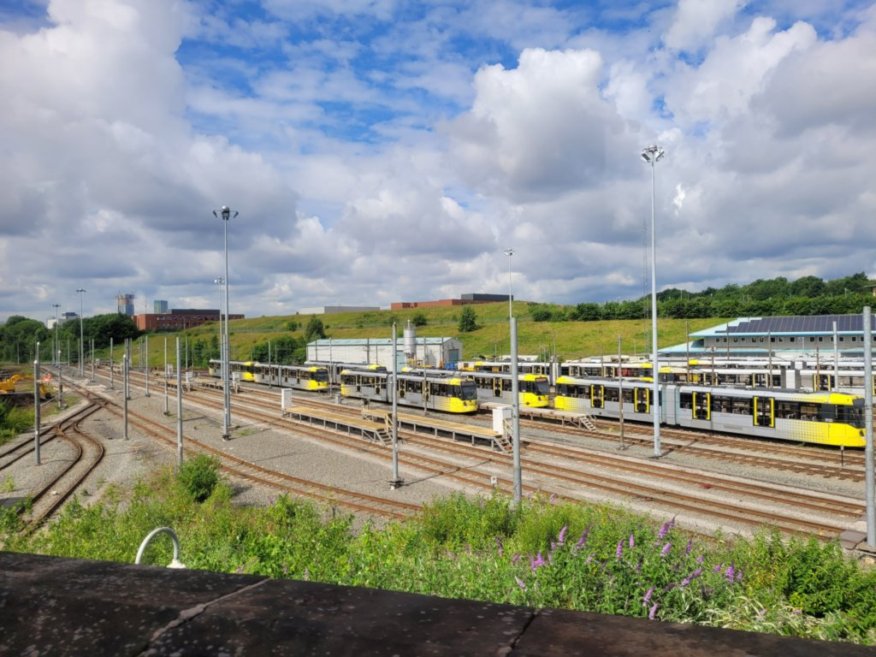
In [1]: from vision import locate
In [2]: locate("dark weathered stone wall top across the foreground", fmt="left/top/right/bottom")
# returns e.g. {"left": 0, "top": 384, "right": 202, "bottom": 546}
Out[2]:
{"left": 0, "top": 552, "right": 874, "bottom": 657}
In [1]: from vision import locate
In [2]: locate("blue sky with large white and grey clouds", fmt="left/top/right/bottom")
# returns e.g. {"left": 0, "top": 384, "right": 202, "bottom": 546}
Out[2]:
{"left": 0, "top": 0, "right": 876, "bottom": 319}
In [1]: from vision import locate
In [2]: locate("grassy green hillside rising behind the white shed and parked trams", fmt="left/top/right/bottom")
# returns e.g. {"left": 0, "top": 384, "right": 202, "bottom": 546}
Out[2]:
{"left": 149, "top": 301, "right": 726, "bottom": 364}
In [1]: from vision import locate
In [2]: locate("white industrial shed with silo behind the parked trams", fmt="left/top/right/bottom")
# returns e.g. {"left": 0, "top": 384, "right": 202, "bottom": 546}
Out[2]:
{"left": 307, "top": 336, "right": 462, "bottom": 371}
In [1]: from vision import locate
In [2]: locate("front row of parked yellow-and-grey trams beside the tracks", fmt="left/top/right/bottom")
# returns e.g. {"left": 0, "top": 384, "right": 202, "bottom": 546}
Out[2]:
{"left": 211, "top": 361, "right": 865, "bottom": 447}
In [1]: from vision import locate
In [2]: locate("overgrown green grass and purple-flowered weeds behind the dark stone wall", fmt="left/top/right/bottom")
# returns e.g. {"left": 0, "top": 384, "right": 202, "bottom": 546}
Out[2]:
{"left": 0, "top": 462, "right": 876, "bottom": 644}
